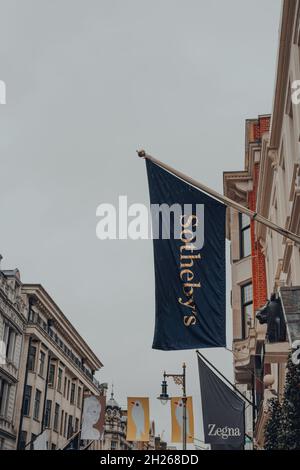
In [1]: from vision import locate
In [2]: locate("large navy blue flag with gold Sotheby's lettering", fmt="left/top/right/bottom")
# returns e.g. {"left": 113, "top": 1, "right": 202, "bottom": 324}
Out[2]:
{"left": 146, "top": 159, "right": 226, "bottom": 351}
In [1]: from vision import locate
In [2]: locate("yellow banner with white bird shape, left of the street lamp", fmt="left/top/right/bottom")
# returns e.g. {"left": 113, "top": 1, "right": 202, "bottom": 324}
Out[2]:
{"left": 126, "top": 397, "right": 150, "bottom": 442}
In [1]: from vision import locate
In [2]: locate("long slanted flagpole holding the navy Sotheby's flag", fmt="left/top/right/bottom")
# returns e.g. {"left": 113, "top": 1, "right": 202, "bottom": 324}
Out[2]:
{"left": 137, "top": 150, "right": 300, "bottom": 245}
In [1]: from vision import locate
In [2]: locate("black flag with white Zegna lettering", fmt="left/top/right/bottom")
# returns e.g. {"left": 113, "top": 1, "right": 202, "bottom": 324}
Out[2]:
{"left": 198, "top": 356, "right": 245, "bottom": 449}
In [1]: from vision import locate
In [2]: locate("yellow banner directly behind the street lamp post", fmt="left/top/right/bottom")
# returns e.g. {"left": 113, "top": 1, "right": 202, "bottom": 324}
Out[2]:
{"left": 171, "top": 397, "right": 194, "bottom": 444}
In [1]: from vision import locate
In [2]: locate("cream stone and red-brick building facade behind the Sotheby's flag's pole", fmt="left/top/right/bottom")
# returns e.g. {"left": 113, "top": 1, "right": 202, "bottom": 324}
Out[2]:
{"left": 224, "top": 0, "right": 300, "bottom": 448}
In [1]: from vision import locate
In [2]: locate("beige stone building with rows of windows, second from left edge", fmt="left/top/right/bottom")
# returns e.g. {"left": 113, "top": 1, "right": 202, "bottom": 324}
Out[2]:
{"left": 15, "top": 284, "right": 102, "bottom": 450}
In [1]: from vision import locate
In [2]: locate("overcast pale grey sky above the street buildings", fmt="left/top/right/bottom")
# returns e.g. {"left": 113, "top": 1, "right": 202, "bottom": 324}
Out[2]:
{"left": 0, "top": 0, "right": 281, "bottom": 446}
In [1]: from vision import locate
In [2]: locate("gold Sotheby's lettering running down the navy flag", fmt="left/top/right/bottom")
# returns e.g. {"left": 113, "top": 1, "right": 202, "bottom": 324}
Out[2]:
{"left": 178, "top": 215, "right": 201, "bottom": 327}
